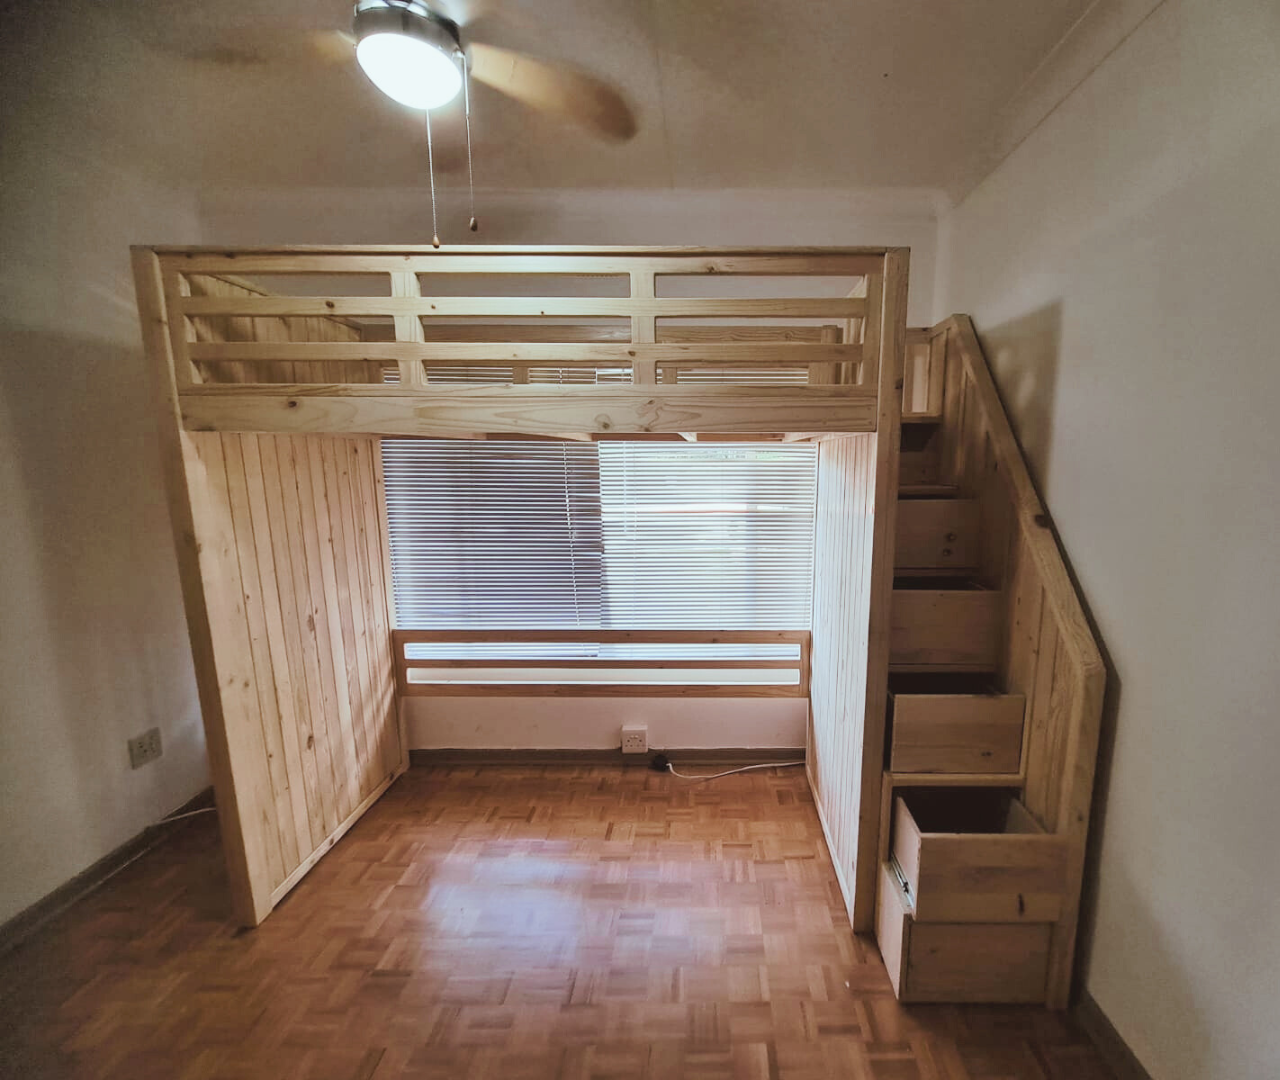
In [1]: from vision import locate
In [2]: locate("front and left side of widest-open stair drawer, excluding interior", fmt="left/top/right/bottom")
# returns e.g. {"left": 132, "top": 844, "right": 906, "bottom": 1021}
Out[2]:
{"left": 892, "top": 796, "right": 1066, "bottom": 924}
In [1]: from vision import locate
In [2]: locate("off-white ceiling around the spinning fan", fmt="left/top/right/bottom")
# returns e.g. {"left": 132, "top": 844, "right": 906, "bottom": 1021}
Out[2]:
{"left": 6, "top": 0, "right": 1089, "bottom": 191}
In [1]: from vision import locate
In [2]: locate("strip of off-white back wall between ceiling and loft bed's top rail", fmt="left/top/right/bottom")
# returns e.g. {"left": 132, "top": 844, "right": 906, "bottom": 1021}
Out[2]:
{"left": 201, "top": 185, "right": 940, "bottom": 325}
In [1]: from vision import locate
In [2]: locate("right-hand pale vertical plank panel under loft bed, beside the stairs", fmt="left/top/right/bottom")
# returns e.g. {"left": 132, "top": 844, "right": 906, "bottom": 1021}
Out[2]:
{"left": 806, "top": 435, "right": 878, "bottom": 914}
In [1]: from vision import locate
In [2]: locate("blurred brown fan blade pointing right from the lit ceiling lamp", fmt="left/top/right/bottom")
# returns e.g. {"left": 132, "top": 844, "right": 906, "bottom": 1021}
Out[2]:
{"left": 468, "top": 42, "right": 637, "bottom": 142}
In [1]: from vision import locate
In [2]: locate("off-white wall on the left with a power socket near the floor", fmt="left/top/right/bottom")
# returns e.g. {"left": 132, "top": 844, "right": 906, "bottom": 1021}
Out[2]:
{"left": 0, "top": 12, "right": 209, "bottom": 921}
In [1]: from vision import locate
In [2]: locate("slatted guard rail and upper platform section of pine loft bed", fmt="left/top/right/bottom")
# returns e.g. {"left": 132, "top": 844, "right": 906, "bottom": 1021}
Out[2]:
{"left": 134, "top": 247, "right": 906, "bottom": 441}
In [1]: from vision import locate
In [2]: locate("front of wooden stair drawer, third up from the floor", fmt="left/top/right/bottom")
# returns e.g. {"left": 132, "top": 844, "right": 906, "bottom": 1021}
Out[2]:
{"left": 888, "top": 694, "right": 1027, "bottom": 773}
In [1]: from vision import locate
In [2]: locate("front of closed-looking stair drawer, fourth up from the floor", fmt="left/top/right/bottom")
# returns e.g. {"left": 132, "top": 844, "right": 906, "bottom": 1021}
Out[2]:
{"left": 888, "top": 587, "right": 1004, "bottom": 671}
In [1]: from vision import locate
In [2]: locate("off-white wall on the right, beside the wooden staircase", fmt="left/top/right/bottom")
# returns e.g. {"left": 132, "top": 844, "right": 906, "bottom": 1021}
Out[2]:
{"left": 937, "top": 0, "right": 1280, "bottom": 1080}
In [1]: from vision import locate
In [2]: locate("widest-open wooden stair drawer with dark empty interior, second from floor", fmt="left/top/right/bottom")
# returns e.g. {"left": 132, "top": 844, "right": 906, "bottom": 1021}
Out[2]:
{"left": 892, "top": 788, "right": 1066, "bottom": 923}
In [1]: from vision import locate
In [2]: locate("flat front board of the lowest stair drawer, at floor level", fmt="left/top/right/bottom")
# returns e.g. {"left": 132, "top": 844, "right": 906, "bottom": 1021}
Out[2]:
{"left": 899, "top": 920, "right": 1051, "bottom": 1003}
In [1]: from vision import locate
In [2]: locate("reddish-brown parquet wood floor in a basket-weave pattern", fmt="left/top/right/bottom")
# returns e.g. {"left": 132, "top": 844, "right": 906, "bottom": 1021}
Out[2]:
{"left": 0, "top": 766, "right": 1110, "bottom": 1080}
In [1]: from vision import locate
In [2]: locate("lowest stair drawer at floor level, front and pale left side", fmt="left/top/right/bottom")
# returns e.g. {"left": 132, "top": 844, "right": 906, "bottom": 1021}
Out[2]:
{"left": 876, "top": 862, "right": 1051, "bottom": 1003}
